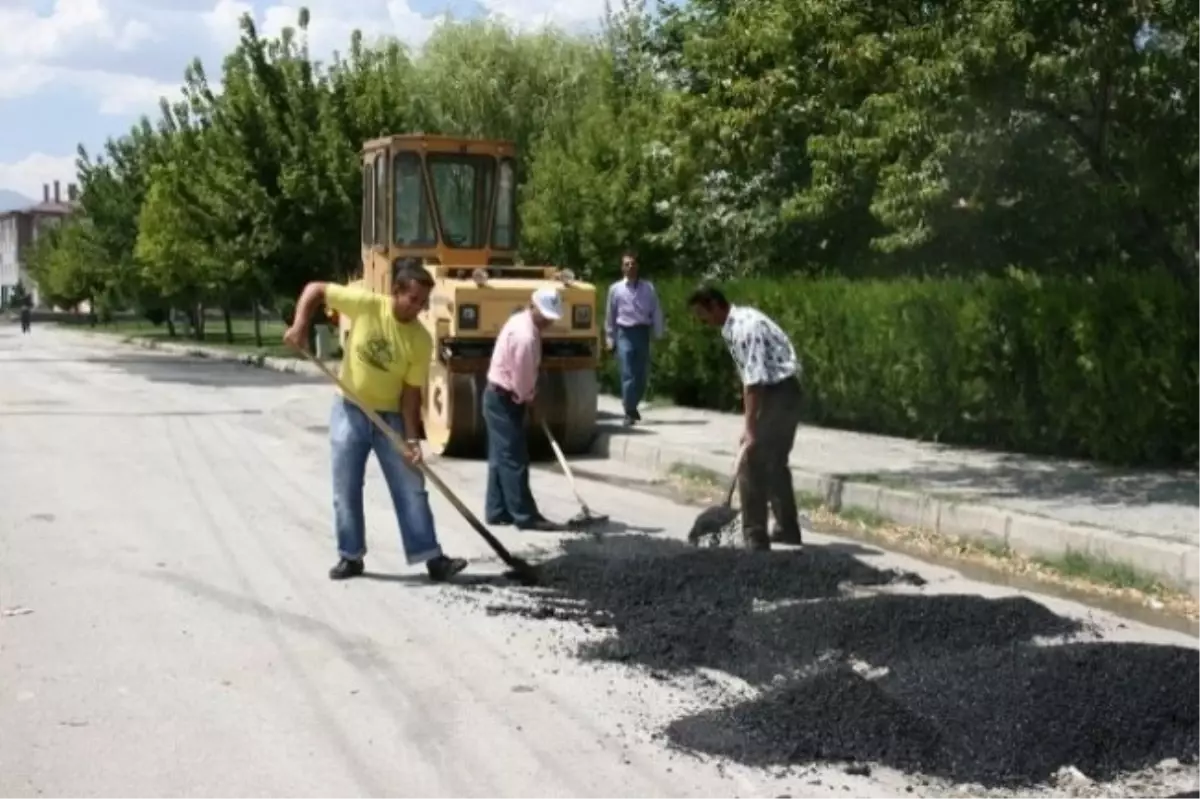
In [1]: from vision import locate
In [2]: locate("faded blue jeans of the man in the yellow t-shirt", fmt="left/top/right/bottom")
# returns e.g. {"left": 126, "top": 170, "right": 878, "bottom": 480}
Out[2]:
{"left": 329, "top": 397, "right": 442, "bottom": 565}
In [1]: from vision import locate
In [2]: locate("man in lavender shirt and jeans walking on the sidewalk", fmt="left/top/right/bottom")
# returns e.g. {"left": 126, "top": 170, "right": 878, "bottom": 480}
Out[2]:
{"left": 605, "top": 250, "right": 664, "bottom": 427}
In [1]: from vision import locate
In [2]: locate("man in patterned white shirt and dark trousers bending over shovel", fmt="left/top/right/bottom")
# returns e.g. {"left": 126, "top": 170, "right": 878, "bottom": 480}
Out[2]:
{"left": 688, "top": 281, "right": 800, "bottom": 549}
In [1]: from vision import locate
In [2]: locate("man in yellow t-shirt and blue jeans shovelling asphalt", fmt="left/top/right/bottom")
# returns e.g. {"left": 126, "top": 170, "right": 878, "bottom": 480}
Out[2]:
{"left": 283, "top": 258, "right": 467, "bottom": 581}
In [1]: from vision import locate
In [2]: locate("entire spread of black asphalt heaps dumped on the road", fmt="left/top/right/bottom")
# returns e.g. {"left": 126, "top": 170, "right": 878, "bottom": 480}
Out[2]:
{"left": 477, "top": 539, "right": 1200, "bottom": 787}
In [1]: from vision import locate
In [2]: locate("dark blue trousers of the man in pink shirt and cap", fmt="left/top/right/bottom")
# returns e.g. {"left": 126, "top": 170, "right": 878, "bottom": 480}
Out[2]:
{"left": 484, "top": 385, "right": 539, "bottom": 527}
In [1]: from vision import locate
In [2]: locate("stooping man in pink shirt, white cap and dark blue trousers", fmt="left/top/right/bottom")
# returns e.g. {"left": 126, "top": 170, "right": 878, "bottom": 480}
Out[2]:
{"left": 484, "top": 288, "right": 563, "bottom": 530}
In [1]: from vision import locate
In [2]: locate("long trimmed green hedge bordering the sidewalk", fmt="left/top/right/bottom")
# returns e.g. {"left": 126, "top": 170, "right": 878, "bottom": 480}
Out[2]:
{"left": 602, "top": 274, "right": 1200, "bottom": 465}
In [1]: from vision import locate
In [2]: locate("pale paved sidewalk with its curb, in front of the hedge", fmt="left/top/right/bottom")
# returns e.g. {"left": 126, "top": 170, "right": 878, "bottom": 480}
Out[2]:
{"left": 593, "top": 397, "right": 1200, "bottom": 596}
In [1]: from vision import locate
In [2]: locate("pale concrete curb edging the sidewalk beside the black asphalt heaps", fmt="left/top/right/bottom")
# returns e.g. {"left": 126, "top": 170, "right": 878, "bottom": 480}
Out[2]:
{"left": 592, "top": 432, "right": 1200, "bottom": 599}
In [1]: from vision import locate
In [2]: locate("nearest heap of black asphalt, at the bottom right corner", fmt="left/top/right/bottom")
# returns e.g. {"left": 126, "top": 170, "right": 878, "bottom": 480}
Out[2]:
{"left": 667, "top": 643, "right": 1200, "bottom": 787}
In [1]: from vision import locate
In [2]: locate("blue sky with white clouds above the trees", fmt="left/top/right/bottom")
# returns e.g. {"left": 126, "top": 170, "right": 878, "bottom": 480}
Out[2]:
{"left": 0, "top": 0, "right": 604, "bottom": 199}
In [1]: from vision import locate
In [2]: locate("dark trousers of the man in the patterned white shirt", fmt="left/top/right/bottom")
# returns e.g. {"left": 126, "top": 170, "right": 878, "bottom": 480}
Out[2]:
{"left": 738, "top": 378, "right": 800, "bottom": 548}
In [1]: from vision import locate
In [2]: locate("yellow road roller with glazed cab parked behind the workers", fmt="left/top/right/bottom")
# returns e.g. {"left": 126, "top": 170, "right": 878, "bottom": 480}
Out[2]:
{"left": 338, "top": 133, "right": 600, "bottom": 457}
